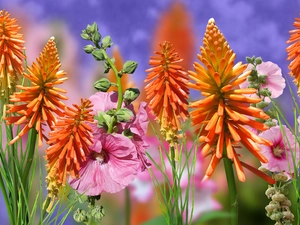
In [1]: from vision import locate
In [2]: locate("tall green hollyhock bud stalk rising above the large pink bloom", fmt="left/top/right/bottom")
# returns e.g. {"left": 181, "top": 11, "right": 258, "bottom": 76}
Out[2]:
{"left": 81, "top": 22, "right": 140, "bottom": 133}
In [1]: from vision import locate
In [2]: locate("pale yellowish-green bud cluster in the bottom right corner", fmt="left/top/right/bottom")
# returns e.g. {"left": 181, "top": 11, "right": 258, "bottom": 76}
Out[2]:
{"left": 260, "top": 168, "right": 294, "bottom": 225}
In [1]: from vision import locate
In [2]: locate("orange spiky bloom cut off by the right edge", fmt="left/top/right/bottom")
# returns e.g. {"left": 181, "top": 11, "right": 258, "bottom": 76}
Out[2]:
{"left": 286, "top": 14, "right": 300, "bottom": 96}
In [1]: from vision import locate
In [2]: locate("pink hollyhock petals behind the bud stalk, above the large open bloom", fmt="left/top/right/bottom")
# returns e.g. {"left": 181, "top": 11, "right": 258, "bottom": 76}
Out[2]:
{"left": 89, "top": 92, "right": 151, "bottom": 171}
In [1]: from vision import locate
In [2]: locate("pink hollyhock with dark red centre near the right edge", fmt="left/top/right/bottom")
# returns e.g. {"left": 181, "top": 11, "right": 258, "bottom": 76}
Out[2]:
{"left": 258, "top": 126, "right": 299, "bottom": 173}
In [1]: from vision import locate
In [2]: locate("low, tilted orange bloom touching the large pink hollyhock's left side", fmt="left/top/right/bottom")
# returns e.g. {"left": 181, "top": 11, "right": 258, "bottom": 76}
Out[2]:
{"left": 45, "top": 99, "right": 94, "bottom": 200}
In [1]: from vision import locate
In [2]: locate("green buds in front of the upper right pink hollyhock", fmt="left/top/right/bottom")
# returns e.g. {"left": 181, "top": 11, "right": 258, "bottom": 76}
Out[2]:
{"left": 246, "top": 56, "right": 276, "bottom": 127}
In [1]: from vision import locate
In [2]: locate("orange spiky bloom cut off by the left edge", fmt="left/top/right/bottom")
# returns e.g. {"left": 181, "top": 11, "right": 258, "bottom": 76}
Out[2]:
{"left": 0, "top": 10, "right": 25, "bottom": 103}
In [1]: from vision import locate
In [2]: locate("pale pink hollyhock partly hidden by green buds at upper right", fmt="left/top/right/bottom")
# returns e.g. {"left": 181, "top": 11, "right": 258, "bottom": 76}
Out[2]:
{"left": 240, "top": 61, "right": 285, "bottom": 102}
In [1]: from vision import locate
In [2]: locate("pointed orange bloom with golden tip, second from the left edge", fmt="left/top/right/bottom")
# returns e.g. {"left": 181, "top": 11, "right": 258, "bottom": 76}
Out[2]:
{"left": 5, "top": 37, "right": 68, "bottom": 146}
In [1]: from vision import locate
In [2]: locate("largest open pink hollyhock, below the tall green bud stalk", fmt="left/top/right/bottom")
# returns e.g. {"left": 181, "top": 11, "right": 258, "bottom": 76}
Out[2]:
{"left": 69, "top": 134, "right": 140, "bottom": 196}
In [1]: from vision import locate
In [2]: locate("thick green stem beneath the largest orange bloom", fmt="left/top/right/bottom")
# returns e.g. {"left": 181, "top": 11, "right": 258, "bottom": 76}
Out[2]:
{"left": 223, "top": 156, "right": 238, "bottom": 225}
